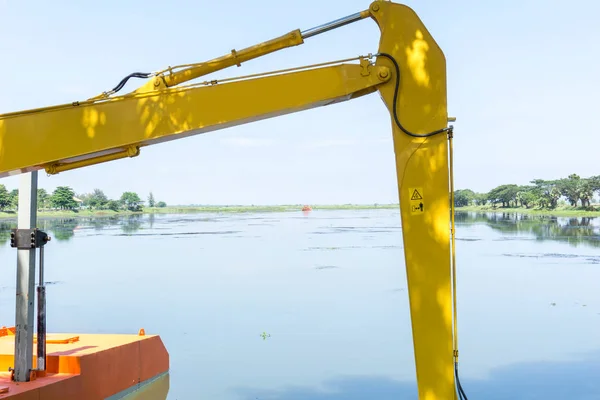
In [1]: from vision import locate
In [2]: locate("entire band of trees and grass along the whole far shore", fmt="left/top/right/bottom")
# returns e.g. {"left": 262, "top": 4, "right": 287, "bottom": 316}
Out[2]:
{"left": 0, "top": 174, "right": 600, "bottom": 218}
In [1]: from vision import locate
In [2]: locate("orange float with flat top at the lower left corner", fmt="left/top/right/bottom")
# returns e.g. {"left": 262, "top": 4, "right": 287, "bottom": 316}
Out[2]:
{"left": 0, "top": 327, "right": 169, "bottom": 400}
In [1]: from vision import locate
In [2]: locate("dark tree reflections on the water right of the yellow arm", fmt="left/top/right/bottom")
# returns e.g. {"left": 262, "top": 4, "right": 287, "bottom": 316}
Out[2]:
{"left": 455, "top": 212, "right": 600, "bottom": 247}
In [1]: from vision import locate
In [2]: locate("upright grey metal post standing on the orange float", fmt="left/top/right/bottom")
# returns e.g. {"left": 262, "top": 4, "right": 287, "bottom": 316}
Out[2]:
{"left": 14, "top": 171, "right": 38, "bottom": 382}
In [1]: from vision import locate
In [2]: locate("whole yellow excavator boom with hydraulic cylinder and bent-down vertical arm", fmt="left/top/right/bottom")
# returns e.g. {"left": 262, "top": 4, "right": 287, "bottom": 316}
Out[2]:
{"left": 0, "top": 1, "right": 457, "bottom": 400}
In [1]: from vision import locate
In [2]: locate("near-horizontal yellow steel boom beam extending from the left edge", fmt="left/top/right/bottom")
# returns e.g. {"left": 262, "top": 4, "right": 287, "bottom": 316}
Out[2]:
{"left": 0, "top": 64, "right": 389, "bottom": 177}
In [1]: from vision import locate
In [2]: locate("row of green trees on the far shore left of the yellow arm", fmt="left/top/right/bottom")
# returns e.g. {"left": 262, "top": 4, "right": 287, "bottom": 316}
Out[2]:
{"left": 0, "top": 184, "right": 167, "bottom": 211}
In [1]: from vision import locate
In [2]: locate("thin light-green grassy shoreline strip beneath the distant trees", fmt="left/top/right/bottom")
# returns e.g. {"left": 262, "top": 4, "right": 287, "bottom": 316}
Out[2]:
{"left": 0, "top": 204, "right": 600, "bottom": 220}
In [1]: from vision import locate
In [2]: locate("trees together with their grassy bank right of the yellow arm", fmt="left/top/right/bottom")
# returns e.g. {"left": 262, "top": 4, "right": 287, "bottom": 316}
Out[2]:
{"left": 454, "top": 174, "right": 600, "bottom": 216}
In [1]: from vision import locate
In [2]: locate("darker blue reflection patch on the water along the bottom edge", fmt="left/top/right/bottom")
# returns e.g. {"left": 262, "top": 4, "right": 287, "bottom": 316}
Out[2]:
{"left": 237, "top": 353, "right": 600, "bottom": 400}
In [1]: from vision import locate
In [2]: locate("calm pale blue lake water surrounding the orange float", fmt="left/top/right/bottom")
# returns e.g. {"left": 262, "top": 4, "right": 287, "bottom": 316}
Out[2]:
{"left": 0, "top": 210, "right": 600, "bottom": 400}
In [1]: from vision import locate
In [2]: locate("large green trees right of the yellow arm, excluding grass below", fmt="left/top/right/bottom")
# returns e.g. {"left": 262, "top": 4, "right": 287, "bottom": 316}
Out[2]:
{"left": 454, "top": 174, "right": 600, "bottom": 210}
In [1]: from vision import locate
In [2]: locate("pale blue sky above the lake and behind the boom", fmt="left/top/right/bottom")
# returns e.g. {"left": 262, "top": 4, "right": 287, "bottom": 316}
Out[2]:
{"left": 0, "top": 0, "right": 600, "bottom": 204}
